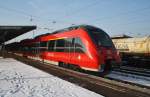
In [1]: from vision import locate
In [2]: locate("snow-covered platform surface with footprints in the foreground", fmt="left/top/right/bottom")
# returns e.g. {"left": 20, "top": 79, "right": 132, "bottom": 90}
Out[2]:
{"left": 0, "top": 58, "right": 102, "bottom": 97}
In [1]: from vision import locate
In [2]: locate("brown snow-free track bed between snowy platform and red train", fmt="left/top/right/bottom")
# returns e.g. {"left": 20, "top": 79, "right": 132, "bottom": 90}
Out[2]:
{"left": 1, "top": 52, "right": 150, "bottom": 97}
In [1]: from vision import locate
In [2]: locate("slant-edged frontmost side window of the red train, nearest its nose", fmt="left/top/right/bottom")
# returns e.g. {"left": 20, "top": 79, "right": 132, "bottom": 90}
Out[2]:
{"left": 74, "top": 38, "right": 86, "bottom": 53}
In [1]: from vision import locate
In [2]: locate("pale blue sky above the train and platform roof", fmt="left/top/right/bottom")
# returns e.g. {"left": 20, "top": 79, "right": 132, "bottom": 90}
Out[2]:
{"left": 0, "top": 0, "right": 150, "bottom": 41}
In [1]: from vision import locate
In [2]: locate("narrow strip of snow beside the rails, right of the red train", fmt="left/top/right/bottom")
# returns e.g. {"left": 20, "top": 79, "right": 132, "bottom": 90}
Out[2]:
{"left": 107, "top": 71, "right": 150, "bottom": 86}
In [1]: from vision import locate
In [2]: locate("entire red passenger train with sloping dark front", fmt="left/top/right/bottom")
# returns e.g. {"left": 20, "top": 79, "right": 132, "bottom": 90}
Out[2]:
{"left": 5, "top": 25, "right": 121, "bottom": 72}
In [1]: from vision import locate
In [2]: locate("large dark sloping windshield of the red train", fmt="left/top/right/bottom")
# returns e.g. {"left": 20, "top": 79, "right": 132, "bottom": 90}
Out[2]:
{"left": 86, "top": 27, "right": 113, "bottom": 47}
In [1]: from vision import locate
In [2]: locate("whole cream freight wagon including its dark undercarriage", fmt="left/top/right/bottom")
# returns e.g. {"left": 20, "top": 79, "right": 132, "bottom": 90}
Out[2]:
{"left": 112, "top": 36, "right": 150, "bottom": 69}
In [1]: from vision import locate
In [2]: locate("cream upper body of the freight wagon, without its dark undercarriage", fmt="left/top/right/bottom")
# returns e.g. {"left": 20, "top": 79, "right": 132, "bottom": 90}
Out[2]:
{"left": 113, "top": 36, "right": 150, "bottom": 57}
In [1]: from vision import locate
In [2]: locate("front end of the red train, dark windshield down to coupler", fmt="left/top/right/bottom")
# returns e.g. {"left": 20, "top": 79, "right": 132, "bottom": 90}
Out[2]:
{"left": 87, "top": 27, "right": 121, "bottom": 72}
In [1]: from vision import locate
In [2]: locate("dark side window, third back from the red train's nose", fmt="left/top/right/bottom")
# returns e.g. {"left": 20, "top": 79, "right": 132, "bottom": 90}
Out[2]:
{"left": 56, "top": 39, "right": 65, "bottom": 52}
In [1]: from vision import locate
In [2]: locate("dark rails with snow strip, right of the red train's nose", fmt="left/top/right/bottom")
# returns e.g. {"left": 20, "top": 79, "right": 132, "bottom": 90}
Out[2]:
{"left": 106, "top": 66, "right": 150, "bottom": 89}
